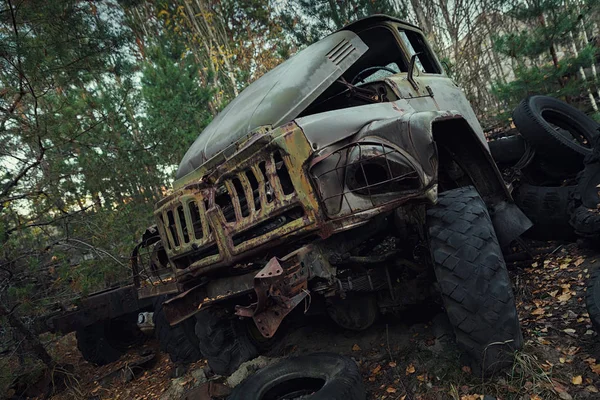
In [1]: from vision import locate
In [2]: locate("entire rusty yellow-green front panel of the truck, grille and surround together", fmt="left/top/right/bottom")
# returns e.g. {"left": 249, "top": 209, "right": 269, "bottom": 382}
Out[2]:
{"left": 155, "top": 123, "right": 319, "bottom": 277}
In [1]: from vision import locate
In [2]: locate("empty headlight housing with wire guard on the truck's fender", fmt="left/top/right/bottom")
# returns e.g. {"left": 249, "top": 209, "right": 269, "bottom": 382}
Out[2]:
{"left": 310, "top": 137, "right": 423, "bottom": 218}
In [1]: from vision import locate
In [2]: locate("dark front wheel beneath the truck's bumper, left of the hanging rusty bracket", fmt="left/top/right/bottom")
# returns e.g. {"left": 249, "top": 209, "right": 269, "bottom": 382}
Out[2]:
{"left": 196, "top": 309, "right": 259, "bottom": 375}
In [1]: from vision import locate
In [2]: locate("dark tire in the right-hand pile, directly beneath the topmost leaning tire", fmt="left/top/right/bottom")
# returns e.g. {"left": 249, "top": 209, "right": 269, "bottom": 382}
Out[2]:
{"left": 513, "top": 184, "right": 577, "bottom": 240}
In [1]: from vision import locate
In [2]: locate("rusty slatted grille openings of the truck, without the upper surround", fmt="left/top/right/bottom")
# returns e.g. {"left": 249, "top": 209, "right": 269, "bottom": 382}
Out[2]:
{"left": 155, "top": 150, "right": 313, "bottom": 269}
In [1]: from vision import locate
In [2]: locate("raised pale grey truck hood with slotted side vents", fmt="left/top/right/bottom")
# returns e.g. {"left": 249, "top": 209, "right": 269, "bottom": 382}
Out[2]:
{"left": 176, "top": 30, "right": 368, "bottom": 179}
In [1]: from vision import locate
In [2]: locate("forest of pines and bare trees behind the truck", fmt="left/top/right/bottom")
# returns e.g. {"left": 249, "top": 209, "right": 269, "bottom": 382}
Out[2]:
{"left": 0, "top": 0, "right": 600, "bottom": 388}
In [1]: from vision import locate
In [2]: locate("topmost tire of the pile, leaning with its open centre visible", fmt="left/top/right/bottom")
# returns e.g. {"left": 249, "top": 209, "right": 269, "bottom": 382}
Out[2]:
{"left": 513, "top": 96, "right": 600, "bottom": 171}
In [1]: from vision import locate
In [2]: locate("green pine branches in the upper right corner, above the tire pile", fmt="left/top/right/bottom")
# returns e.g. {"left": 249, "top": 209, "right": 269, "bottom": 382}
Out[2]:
{"left": 492, "top": 0, "right": 597, "bottom": 115}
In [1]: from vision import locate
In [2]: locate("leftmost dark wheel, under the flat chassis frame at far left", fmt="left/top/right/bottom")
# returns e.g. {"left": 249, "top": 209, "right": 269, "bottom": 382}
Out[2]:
{"left": 75, "top": 314, "right": 144, "bottom": 365}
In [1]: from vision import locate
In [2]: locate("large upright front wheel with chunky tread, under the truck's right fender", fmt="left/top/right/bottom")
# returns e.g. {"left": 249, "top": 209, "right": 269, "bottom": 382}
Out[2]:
{"left": 427, "top": 186, "right": 523, "bottom": 375}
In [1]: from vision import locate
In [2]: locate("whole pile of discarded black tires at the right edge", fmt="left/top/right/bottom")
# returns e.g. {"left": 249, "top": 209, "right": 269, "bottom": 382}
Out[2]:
{"left": 489, "top": 96, "right": 600, "bottom": 240}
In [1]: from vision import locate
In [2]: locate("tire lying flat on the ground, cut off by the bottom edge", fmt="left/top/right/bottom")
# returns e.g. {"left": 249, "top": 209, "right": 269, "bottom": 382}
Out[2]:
{"left": 228, "top": 353, "right": 366, "bottom": 400}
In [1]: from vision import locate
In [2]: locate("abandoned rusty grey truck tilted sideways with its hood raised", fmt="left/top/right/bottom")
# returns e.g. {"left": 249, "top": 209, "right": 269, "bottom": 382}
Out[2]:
{"left": 134, "top": 15, "right": 531, "bottom": 374}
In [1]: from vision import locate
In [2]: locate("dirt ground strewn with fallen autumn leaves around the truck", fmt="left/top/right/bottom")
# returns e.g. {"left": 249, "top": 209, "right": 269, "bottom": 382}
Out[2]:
{"left": 38, "top": 239, "right": 600, "bottom": 400}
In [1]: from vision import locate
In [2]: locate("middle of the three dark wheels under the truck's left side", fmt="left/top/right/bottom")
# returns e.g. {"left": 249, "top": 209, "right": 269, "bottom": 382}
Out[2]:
{"left": 152, "top": 296, "right": 202, "bottom": 364}
